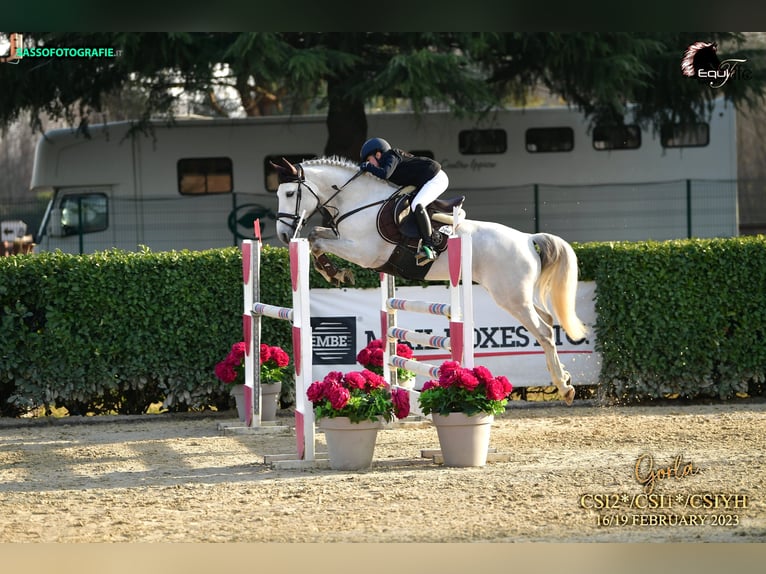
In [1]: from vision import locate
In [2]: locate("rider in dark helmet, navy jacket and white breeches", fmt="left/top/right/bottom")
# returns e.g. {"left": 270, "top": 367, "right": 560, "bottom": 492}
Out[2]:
{"left": 359, "top": 138, "right": 449, "bottom": 265}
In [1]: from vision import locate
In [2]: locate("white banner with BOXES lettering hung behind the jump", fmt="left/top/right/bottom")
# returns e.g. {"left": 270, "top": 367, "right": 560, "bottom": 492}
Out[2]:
{"left": 311, "top": 282, "right": 601, "bottom": 388}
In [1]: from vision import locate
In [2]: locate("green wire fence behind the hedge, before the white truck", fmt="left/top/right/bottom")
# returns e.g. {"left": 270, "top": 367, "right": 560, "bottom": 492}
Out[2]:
{"left": 0, "top": 180, "right": 766, "bottom": 252}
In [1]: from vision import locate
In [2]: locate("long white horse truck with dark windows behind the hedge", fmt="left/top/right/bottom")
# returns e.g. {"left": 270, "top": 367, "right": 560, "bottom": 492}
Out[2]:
{"left": 31, "top": 99, "right": 738, "bottom": 253}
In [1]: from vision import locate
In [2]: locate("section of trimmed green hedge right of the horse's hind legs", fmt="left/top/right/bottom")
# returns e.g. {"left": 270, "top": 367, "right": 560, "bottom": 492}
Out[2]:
{"left": 576, "top": 236, "right": 766, "bottom": 400}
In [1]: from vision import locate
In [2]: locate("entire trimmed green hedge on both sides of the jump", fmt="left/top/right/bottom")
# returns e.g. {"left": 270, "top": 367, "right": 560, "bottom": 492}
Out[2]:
{"left": 0, "top": 237, "right": 766, "bottom": 416}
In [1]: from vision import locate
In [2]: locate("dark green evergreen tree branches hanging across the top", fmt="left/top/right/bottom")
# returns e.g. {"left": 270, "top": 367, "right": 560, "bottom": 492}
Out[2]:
{"left": 0, "top": 32, "right": 766, "bottom": 157}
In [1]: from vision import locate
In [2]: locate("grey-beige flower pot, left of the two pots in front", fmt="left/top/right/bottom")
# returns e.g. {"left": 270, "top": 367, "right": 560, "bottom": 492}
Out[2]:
{"left": 319, "top": 417, "right": 383, "bottom": 470}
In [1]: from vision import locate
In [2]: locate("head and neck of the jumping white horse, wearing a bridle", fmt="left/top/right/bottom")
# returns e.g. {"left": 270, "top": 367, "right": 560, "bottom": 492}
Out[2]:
{"left": 271, "top": 156, "right": 390, "bottom": 243}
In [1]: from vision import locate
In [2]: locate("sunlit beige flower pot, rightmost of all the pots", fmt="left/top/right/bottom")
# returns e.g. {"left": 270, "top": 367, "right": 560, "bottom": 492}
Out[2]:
{"left": 431, "top": 413, "right": 495, "bottom": 466}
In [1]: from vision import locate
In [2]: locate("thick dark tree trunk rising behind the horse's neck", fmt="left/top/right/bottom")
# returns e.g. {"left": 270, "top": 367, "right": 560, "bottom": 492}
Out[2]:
{"left": 324, "top": 80, "right": 367, "bottom": 162}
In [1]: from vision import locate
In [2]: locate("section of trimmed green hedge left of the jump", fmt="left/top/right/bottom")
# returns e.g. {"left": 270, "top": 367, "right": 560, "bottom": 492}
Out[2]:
{"left": 0, "top": 248, "right": 280, "bottom": 414}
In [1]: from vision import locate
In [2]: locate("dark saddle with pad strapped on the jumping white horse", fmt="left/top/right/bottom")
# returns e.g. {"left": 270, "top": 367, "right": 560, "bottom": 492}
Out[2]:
{"left": 376, "top": 187, "right": 465, "bottom": 280}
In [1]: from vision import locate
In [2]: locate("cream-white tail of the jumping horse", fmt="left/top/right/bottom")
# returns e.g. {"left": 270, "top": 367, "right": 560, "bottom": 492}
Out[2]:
{"left": 532, "top": 233, "right": 588, "bottom": 341}
